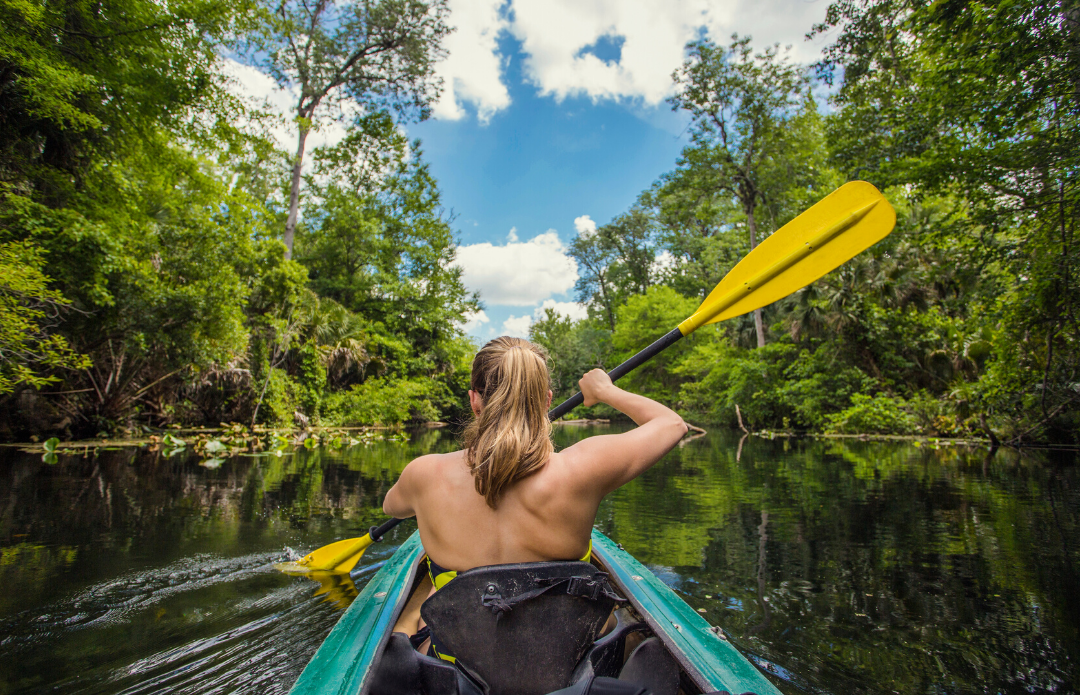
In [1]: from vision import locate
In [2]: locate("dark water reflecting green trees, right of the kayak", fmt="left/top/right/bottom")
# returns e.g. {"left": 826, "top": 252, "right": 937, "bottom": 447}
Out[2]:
{"left": 591, "top": 436, "right": 1080, "bottom": 693}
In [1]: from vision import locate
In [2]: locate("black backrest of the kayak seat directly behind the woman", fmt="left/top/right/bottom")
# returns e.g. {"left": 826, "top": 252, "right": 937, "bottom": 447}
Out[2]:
{"left": 420, "top": 561, "right": 625, "bottom": 695}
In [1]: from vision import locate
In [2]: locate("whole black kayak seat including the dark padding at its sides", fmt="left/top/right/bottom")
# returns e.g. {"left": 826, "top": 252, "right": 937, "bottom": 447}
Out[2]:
{"left": 363, "top": 562, "right": 679, "bottom": 695}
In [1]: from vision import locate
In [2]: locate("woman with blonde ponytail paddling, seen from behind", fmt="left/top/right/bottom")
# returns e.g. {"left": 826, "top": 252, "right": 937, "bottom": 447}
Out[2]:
{"left": 382, "top": 337, "right": 687, "bottom": 591}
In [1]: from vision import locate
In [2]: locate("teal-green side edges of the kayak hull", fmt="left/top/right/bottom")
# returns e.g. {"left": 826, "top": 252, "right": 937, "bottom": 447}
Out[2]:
{"left": 289, "top": 531, "right": 780, "bottom": 695}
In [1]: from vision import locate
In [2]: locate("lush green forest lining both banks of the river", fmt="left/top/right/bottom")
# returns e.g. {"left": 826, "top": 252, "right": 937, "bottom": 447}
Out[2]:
{"left": 0, "top": 0, "right": 1080, "bottom": 445}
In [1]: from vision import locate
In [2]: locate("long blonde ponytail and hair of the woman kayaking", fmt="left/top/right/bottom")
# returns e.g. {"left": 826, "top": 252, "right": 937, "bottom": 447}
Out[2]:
{"left": 464, "top": 336, "right": 555, "bottom": 509}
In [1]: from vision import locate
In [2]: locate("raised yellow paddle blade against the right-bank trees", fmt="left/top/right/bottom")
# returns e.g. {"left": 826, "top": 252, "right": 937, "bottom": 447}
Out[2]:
{"left": 678, "top": 181, "right": 896, "bottom": 336}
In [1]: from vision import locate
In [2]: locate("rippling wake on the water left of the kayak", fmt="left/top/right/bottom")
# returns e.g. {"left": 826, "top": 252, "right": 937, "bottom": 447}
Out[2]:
{"left": 0, "top": 548, "right": 380, "bottom": 695}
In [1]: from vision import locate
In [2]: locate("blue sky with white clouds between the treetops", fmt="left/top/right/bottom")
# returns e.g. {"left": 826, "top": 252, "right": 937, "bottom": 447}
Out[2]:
{"left": 234, "top": 0, "right": 828, "bottom": 340}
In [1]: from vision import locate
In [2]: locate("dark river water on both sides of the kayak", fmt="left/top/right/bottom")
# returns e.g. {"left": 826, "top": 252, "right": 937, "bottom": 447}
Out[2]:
{"left": 0, "top": 427, "right": 1080, "bottom": 694}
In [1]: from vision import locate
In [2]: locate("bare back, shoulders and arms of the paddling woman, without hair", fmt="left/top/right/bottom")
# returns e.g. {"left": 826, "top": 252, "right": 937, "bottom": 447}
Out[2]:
{"left": 382, "top": 369, "right": 686, "bottom": 572}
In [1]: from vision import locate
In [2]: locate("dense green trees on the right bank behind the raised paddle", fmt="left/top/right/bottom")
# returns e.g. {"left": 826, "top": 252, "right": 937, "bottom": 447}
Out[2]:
{"left": 532, "top": 0, "right": 1080, "bottom": 442}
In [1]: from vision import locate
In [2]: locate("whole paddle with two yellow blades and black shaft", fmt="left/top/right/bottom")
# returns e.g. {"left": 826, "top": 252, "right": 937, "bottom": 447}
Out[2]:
{"left": 274, "top": 181, "right": 896, "bottom": 572}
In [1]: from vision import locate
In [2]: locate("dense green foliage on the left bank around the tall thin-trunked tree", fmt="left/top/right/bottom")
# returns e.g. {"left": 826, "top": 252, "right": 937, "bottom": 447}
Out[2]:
{"left": 0, "top": 0, "right": 476, "bottom": 437}
